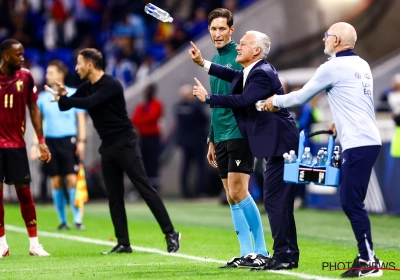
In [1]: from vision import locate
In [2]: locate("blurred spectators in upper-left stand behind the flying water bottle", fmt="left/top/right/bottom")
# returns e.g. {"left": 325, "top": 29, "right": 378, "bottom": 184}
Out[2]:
{"left": 0, "top": 0, "right": 254, "bottom": 87}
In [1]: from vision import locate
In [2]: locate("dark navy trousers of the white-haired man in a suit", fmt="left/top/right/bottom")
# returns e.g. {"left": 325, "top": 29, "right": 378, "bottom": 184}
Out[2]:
{"left": 264, "top": 157, "right": 300, "bottom": 263}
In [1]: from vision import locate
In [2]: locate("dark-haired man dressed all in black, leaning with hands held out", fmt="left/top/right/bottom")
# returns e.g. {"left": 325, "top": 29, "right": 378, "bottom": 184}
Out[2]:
{"left": 45, "top": 48, "right": 181, "bottom": 254}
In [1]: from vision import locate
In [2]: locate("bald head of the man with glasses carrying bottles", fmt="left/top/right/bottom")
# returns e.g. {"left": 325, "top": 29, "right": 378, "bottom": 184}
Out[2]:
{"left": 324, "top": 22, "right": 357, "bottom": 55}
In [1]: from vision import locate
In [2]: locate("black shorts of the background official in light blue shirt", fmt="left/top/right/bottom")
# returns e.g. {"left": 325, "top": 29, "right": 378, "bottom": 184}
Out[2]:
{"left": 45, "top": 136, "right": 79, "bottom": 177}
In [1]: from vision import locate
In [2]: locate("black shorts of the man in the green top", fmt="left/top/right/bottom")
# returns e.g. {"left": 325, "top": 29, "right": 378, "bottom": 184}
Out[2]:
{"left": 215, "top": 138, "right": 254, "bottom": 179}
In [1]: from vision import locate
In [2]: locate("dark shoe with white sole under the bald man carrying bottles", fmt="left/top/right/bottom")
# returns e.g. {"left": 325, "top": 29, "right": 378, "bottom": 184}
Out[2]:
{"left": 340, "top": 256, "right": 383, "bottom": 278}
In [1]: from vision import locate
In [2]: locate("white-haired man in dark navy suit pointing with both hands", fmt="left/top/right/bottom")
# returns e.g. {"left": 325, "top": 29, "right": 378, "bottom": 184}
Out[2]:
{"left": 189, "top": 31, "right": 299, "bottom": 270}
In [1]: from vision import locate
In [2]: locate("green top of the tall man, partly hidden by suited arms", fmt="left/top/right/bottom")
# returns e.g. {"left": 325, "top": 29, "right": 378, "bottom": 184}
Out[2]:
{"left": 208, "top": 40, "right": 243, "bottom": 143}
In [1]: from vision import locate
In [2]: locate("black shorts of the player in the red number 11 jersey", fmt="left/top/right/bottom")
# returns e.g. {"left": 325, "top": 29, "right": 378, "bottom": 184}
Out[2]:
{"left": 0, "top": 148, "right": 31, "bottom": 185}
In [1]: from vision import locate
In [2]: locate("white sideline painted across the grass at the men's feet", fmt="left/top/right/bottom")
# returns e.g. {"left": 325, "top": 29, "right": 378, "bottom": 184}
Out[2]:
{"left": 5, "top": 225, "right": 335, "bottom": 280}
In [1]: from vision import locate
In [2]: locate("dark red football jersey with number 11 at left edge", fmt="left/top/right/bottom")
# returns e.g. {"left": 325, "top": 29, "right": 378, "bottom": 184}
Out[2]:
{"left": 0, "top": 68, "right": 38, "bottom": 148}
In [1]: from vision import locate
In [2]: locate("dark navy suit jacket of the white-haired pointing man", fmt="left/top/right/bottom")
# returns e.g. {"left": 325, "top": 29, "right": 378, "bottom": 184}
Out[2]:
{"left": 208, "top": 60, "right": 299, "bottom": 158}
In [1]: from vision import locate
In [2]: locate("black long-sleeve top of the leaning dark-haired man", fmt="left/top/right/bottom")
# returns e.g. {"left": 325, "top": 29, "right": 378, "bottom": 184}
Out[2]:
{"left": 58, "top": 74, "right": 136, "bottom": 145}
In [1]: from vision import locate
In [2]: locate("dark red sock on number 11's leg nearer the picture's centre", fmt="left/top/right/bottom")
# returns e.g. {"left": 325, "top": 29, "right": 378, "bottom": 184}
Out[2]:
{"left": 15, "top": 185, "right": 37, "bottom": 237}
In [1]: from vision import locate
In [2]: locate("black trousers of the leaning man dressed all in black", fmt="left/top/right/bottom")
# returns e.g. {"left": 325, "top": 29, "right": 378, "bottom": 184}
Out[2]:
{"left": 99, "top": 139, "right": 174, "bottom": 246}
